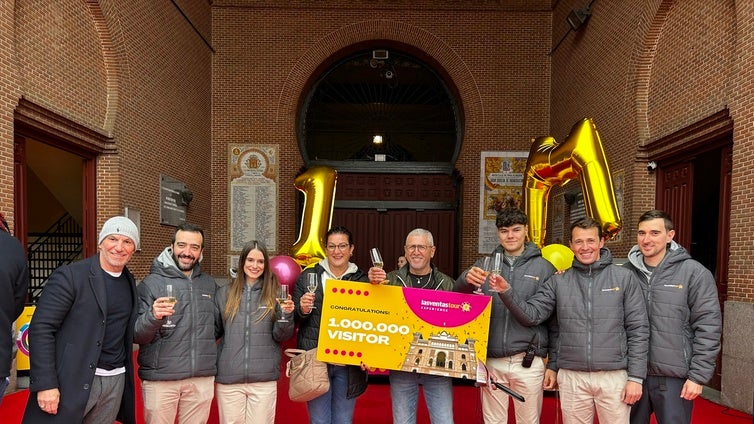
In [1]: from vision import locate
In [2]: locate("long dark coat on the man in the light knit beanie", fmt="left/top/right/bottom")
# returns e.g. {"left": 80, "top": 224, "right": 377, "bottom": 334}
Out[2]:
{"left": 23, "top": 255, "right": 136, "bottom": 424}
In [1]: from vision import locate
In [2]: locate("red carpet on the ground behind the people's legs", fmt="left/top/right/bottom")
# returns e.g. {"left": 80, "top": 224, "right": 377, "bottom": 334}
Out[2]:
{"left": 0, "top": 350, "right": 752, "bottom": 424}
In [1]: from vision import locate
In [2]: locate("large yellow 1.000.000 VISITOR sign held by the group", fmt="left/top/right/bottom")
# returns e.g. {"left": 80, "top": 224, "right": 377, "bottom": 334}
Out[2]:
{"left": 317, "top": 280, "right": 492, "bottom": 380}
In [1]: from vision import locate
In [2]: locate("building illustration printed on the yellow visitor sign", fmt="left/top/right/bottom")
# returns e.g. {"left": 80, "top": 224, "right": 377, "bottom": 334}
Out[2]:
{"left": 401, "top": 331, "right": 477, "bottom": 379}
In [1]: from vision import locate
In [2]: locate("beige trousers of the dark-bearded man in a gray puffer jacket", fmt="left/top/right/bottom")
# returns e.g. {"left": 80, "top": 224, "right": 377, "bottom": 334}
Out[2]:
{"left": 141, "top": 377, "right": 215, "bottom": 424}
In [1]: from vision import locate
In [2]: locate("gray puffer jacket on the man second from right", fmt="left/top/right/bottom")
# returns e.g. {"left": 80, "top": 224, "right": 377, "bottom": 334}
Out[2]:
{"left": 500, "top": 248, "right": 649, "bottom": 380}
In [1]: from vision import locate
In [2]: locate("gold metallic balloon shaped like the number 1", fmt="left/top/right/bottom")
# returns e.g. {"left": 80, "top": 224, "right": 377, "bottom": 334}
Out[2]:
{"left": 290, "top": 166, "right": 338, "bottom": 267}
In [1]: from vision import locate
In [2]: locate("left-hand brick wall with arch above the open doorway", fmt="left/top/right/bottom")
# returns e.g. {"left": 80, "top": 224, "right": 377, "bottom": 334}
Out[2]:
{"left": 5, "top": 0, "right": 212, "bottom": 277}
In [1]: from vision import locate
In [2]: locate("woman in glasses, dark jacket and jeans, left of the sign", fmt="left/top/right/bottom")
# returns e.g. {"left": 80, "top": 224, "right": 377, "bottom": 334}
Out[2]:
{"left": 293, "top": 227, "right": 368, "bottom": 424}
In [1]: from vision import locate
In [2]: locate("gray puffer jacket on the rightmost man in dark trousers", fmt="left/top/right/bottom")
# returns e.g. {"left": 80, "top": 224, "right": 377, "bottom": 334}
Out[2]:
{"left": 624, "top": 241, "right": 722, "bottom": 384}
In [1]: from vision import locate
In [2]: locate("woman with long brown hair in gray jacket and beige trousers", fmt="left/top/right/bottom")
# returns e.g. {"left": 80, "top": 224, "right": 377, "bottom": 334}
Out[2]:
{"left": 215, "top": 240, "right": 294, "bottom": 424}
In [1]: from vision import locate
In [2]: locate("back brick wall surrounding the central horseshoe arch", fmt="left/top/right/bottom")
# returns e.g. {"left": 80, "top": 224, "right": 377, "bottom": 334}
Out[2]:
{"left": 212, "top": 1, "right": 550, "bottom": 274}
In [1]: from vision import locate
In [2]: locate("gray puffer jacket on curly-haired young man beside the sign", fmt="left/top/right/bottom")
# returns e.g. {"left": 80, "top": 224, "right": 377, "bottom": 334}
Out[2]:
{"left": 455, "top": 242, "right": 555, "bottom": 363}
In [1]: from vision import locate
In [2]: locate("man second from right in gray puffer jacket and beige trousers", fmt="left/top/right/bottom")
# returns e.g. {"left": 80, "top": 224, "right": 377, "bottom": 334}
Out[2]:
{"left": 490, "top": 218, "right": 649, "bottom": 424}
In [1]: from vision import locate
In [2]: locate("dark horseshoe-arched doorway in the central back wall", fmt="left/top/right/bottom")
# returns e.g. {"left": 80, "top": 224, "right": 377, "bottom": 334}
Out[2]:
{"left": 298, "top": 43, "right": 463, "bottom": 275}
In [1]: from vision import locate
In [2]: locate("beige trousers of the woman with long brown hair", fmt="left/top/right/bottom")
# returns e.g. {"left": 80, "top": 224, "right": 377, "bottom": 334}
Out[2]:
{"left": 215, "top": 381, "right": 278, "bottom": 424}
